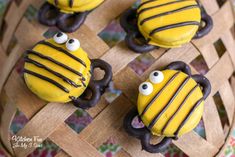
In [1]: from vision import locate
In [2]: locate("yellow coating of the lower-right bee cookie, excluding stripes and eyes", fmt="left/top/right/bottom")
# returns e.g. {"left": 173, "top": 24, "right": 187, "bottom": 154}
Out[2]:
{"left": 137, "top": 70, "right": 204, "bottom": 137}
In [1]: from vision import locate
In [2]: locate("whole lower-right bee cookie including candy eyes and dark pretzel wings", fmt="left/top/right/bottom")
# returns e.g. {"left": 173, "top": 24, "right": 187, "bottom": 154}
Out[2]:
{"left": 124, "top": 62, "right": 211, "bottom": 153}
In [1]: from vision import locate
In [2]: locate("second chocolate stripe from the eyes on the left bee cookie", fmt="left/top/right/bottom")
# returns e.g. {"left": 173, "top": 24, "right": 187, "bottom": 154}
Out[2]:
{"left": 27, "top": 50, "right": 85, "bottom": 79}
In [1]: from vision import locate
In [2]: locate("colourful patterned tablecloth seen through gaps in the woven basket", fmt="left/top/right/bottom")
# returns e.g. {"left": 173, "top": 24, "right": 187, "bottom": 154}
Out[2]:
{"left": 0, "top": 0, "right": 235, "bottom": 157}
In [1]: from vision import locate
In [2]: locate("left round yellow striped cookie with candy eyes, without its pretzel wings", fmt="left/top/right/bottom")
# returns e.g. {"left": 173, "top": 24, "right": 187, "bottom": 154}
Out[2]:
{"left": 24, "top": 32, "right": 91, "bottom": 103}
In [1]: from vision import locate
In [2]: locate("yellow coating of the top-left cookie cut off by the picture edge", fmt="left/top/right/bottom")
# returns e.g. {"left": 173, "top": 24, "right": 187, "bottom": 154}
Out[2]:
{"left": 47, "top": 0, "right": 104, "bottom": 13}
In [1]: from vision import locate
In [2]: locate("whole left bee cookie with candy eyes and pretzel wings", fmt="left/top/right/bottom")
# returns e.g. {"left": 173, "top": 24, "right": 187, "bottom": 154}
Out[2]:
{"left": 24, "top": 32, "right": 112, "bottom": 109}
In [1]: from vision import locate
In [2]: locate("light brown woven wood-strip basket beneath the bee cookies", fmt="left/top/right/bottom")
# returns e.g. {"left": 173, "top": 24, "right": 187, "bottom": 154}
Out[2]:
{"left": 0, "top": 0, "right": 235, "bottom": 157}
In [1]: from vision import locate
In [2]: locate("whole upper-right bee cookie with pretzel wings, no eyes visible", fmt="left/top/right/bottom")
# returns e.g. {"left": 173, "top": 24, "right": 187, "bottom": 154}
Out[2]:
{"left": 120, "top": 0, "right": 213, "bottom": 53}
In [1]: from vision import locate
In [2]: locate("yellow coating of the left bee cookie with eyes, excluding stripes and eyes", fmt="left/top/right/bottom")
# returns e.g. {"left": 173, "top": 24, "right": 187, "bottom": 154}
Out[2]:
{"left": 24, "top": 39, "right": 91, "bottom": 103}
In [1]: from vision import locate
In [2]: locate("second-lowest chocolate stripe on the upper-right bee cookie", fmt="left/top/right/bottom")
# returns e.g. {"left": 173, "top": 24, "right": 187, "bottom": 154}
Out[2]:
{"left": 140, "top": 5, "right": 198, "bottom": 25}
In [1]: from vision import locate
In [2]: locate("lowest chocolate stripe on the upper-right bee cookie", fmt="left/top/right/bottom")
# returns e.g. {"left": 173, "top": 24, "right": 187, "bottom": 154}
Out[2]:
{"left": 149, "top": 21, "right": 200, "bottom": 36}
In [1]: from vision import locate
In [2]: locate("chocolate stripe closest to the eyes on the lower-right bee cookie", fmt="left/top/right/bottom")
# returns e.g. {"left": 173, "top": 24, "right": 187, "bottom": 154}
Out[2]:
{"left": 140, "top": 71, "right": 180, "bottom": 117}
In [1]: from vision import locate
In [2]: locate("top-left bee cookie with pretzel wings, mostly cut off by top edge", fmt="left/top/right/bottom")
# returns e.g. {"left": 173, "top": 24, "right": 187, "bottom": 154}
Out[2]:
{"left": 38, "top": 0, "right": 104, "bottom": 32}
